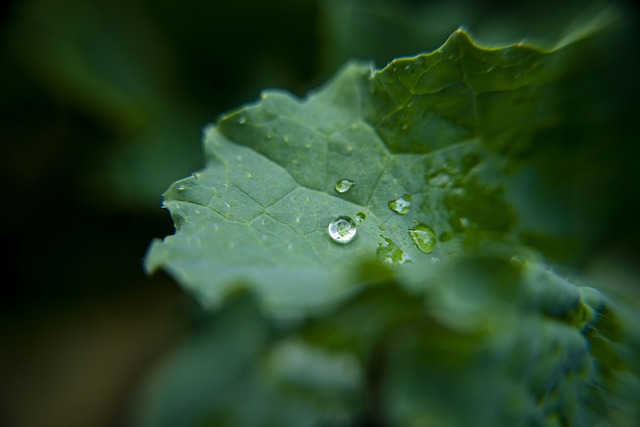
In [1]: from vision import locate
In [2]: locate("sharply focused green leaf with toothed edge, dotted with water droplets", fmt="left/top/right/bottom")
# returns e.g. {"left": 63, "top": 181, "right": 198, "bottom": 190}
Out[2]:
{"left": 146, "top": 25, "right": 612, "bottom": 312}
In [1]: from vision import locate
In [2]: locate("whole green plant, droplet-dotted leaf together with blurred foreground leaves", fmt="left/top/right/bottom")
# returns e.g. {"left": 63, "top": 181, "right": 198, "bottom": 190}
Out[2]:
{"left": 139, "top": 6, "right": 640, "bottom": 426}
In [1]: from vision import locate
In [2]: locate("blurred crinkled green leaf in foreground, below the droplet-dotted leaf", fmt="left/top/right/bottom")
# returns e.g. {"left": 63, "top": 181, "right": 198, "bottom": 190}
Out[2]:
{"left": 133, "top": 257, "right": 640, "bottom": 427}
